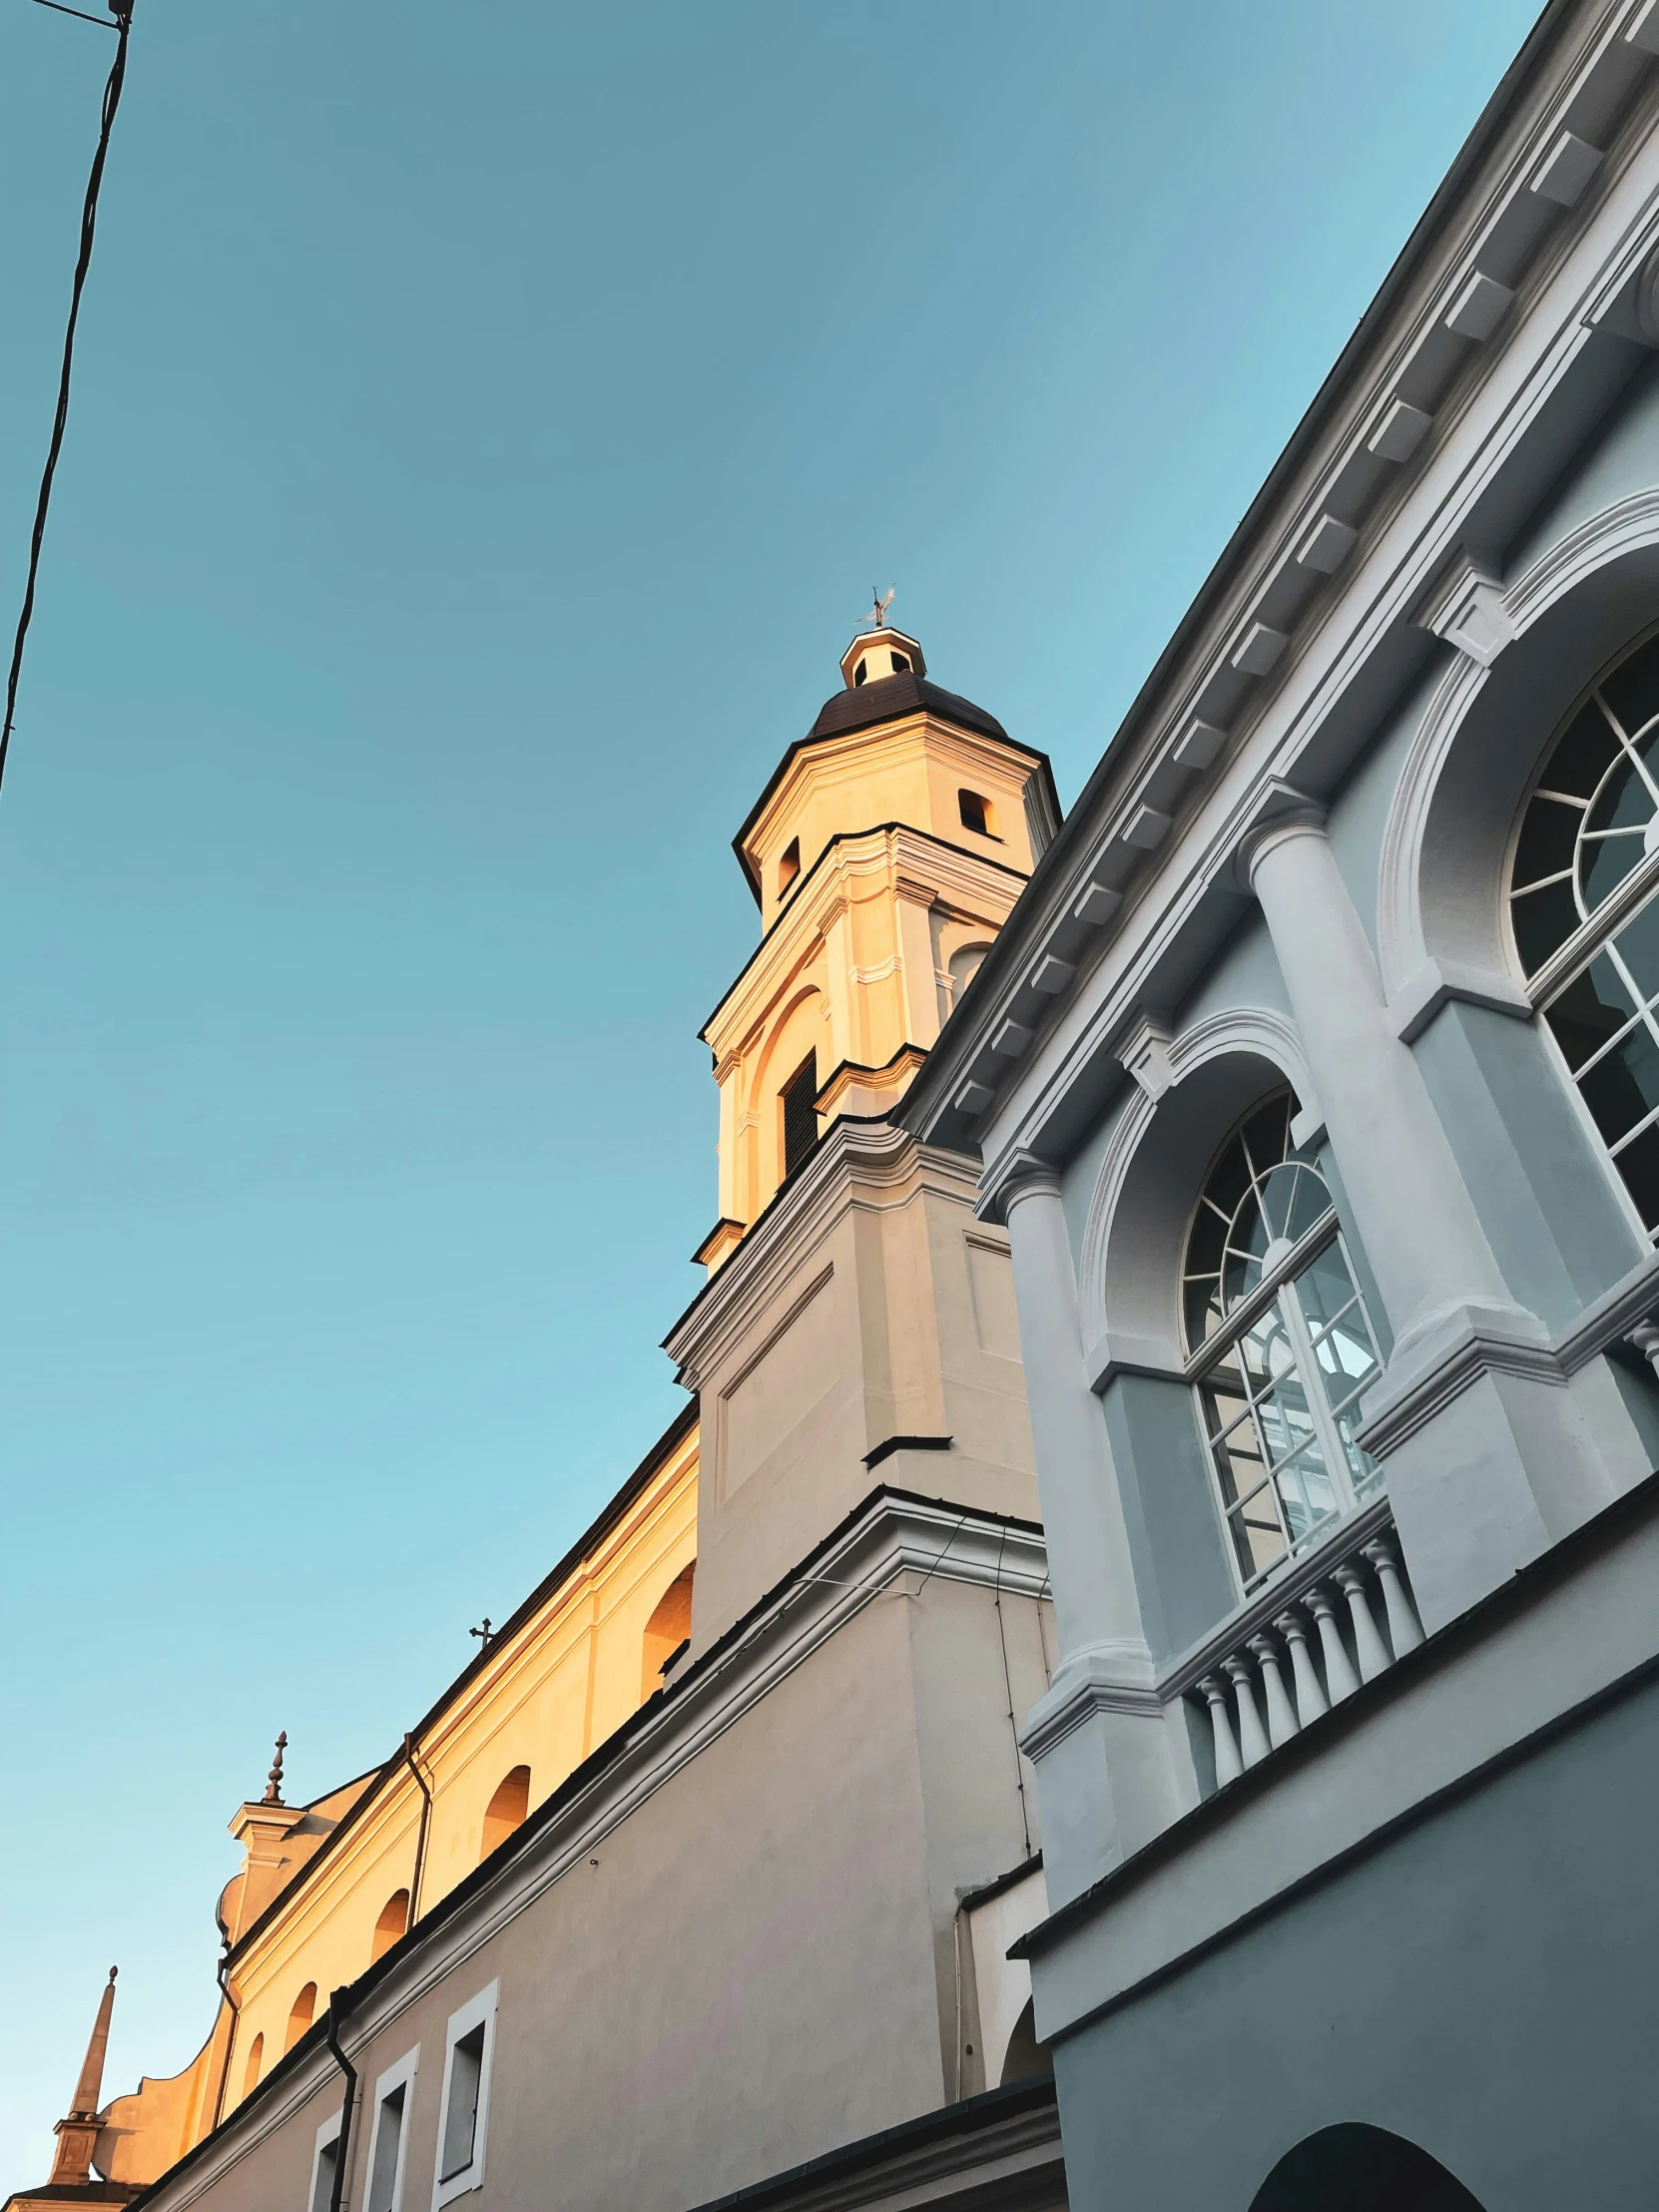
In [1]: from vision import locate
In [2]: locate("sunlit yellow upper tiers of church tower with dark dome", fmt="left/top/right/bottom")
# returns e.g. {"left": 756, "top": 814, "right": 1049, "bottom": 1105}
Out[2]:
{"left": 695, "top": 624, "right": 1059, "bottom": 1274}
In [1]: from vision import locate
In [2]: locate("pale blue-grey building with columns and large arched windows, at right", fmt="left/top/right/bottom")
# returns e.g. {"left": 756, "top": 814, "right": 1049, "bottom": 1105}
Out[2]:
{"left": 904, "top": 0, "right": 1659, "bottom": 2212}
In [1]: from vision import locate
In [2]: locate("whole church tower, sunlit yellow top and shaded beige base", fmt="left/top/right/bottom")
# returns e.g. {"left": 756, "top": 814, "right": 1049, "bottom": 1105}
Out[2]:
{"left": 668, "top": 622, "right": 1059, "bottom": 1655}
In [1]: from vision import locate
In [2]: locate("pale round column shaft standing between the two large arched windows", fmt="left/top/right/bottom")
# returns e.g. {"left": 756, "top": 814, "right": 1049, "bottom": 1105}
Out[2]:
{"left": 1243, "top": 810, "right": 1513, "bottom": 1339}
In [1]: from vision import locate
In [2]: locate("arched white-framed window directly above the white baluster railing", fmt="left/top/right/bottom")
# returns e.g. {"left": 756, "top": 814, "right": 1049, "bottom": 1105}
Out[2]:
{"left": 1181, "top": 1090, "right": 1379, "bottom": 1593}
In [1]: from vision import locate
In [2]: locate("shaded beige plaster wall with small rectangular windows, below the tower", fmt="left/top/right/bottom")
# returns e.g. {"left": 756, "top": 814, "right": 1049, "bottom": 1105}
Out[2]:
{"left": 146, "top": 1577, "right": 1040, "bottom": 2212}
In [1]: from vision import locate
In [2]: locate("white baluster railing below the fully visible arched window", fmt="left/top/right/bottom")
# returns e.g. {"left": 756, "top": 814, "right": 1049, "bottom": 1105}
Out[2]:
{"left": 1159, "top": 1497, "right": 1422, "bottom": 1796}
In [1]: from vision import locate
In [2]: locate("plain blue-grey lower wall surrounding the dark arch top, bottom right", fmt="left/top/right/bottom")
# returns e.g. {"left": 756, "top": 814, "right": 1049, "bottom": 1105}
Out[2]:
{"left": 1055, "top": 1688, "right": 1659, "bottom": 2212}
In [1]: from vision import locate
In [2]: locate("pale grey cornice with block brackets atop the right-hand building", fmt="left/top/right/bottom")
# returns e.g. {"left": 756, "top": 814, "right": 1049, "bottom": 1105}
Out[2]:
{"left": 911, "top": 4, "right": 1659, "bottom": 1141}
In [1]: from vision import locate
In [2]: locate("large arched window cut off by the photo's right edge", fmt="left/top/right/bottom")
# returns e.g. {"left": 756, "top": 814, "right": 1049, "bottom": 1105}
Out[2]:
{"left": 1508, "top": 635, "right": 1659, "bottom": 1237}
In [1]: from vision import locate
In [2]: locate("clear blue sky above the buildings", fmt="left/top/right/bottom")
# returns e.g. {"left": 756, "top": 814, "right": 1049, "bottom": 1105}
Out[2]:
{"left": 0, "top": 0, "right": 1533, "bottom": 2192}
